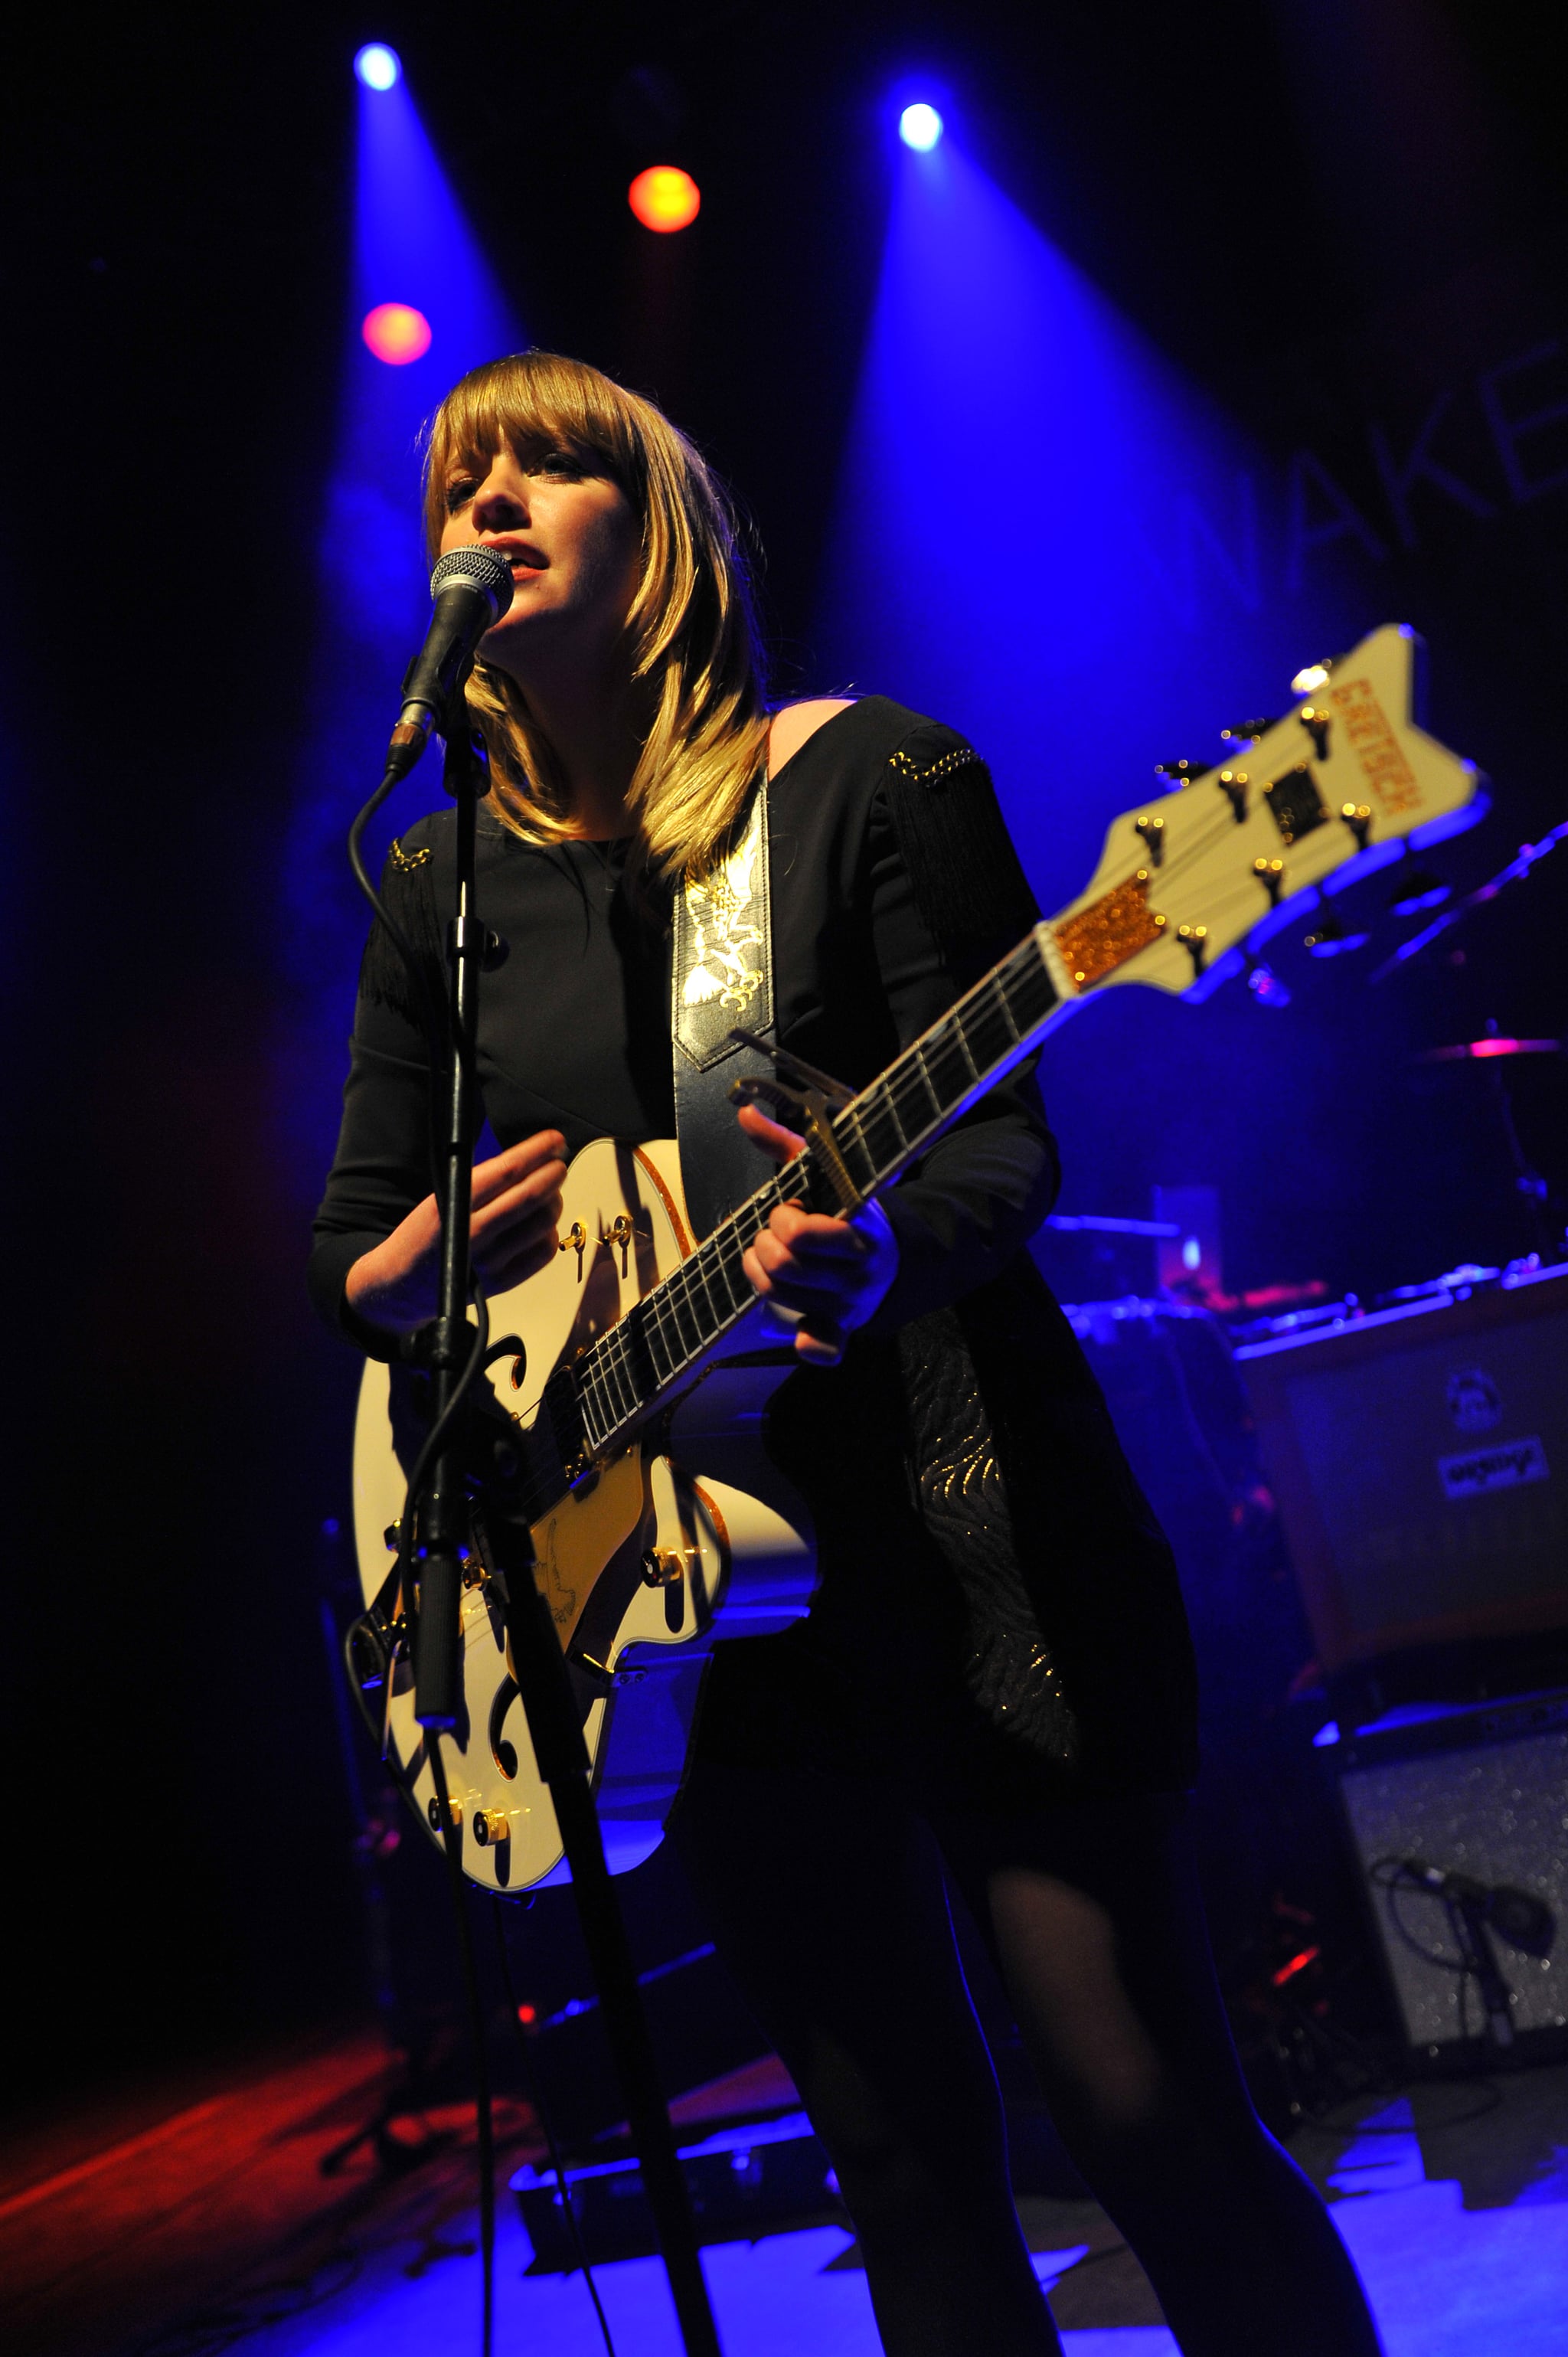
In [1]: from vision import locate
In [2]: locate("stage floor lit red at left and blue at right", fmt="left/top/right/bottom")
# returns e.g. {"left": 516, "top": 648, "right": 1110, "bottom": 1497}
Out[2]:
{"left": 0, "top": 2042, "right": 1568, "bottom": 2357}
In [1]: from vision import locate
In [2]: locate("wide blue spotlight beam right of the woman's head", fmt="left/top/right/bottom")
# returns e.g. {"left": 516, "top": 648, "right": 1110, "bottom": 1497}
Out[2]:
{"left": 816, "top": 134, "right": 1363, "bottom": 907}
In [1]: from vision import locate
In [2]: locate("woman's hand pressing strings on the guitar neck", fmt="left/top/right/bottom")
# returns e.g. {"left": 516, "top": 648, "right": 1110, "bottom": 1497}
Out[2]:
{"left": 740, "top": 1106, "right": 898, "bottom": 1367}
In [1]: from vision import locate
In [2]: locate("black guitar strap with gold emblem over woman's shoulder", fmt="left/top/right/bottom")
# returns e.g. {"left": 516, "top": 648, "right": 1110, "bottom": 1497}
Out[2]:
{"left": 672, "top": 773, "right": 776, "bottom": 1240}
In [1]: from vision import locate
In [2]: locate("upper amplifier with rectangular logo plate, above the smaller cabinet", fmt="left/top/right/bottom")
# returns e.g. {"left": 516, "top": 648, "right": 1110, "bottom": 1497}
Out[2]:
{"left": 1236, "top": 1266, "right": 1568, "bottom": 1675}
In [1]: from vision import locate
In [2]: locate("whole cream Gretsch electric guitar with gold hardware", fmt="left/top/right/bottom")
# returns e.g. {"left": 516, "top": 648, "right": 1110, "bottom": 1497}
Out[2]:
{"left": 354, "top": 625, "right": 1485, "bottom": 1891}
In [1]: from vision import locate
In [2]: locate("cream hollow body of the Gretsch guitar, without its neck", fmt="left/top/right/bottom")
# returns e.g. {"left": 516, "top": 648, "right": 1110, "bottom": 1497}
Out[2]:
{"left": 354, "top": 1139, "right": 816, "bottom": 1891}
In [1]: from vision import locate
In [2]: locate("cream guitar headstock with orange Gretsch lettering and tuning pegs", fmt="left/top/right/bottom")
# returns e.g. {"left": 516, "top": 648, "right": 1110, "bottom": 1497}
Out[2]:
{"left": 1047, "top": 623, "right": 1485, "bottom": 999}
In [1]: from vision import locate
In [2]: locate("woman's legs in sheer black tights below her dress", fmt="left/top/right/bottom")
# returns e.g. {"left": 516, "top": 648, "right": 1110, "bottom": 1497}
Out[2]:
{"left": 672, "top": 1765, "right": 1380, "bottom": 2357}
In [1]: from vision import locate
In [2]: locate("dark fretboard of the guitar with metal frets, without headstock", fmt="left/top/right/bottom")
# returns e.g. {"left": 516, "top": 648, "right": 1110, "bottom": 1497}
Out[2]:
{"left": 556, "top": 927, "right": 1057, "bottom": 1456}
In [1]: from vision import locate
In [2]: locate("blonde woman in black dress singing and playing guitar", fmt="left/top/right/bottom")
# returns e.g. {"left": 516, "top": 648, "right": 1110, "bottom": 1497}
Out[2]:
{"left": 312, "top": 351, "right": 1377, "bottom": 2357}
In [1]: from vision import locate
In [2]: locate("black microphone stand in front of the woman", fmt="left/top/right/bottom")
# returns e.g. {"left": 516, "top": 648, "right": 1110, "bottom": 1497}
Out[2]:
{"left": 413, "top": 674, "right": 721, "bottom": 2357}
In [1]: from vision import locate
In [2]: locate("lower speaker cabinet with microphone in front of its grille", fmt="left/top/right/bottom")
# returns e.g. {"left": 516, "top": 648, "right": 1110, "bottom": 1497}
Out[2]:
{"left": 1330, "top": 1692, "right": 1568, "bottom": 2064}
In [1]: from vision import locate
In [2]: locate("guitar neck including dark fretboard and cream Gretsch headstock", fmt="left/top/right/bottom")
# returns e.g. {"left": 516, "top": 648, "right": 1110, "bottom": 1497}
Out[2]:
{"left": 547, "top": 625, "right": 1485, "bottom": 1466}
